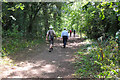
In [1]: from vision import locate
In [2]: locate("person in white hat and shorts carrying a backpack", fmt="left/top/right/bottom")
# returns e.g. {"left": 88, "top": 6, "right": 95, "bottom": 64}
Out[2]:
{"left": 46, "top": 25, "right": 56, "bottom": 52}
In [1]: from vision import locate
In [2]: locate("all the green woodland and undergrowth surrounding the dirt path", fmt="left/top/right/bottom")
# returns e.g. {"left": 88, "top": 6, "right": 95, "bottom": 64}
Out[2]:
{"left": 1, "top": 1, "right": 120, "bottom": 78}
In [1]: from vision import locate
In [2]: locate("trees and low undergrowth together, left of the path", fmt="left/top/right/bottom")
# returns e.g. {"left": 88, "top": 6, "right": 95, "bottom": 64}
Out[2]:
{"left": 2, "top": 2, "right": 66, "bottom": 56}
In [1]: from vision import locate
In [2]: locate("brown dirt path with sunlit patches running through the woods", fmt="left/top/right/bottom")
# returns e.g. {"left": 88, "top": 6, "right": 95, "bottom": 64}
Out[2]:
{"left": 1, "top": 34, "right": 84, "bottom": 78}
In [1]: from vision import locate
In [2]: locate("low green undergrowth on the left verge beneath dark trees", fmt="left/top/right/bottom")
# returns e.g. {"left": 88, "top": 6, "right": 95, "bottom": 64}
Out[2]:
{"left": 1, "top": 26, "right": 45, "bottom": 57}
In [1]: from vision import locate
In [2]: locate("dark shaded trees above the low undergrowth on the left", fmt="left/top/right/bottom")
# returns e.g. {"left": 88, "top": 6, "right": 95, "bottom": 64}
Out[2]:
{"left": 2, "top": 2, "right": 64, "bottom": 38}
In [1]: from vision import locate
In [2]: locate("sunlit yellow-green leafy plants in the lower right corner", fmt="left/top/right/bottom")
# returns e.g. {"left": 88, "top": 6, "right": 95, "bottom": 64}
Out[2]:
{"left": 90, "top": 37, "right": 119, "bottom": 78}
